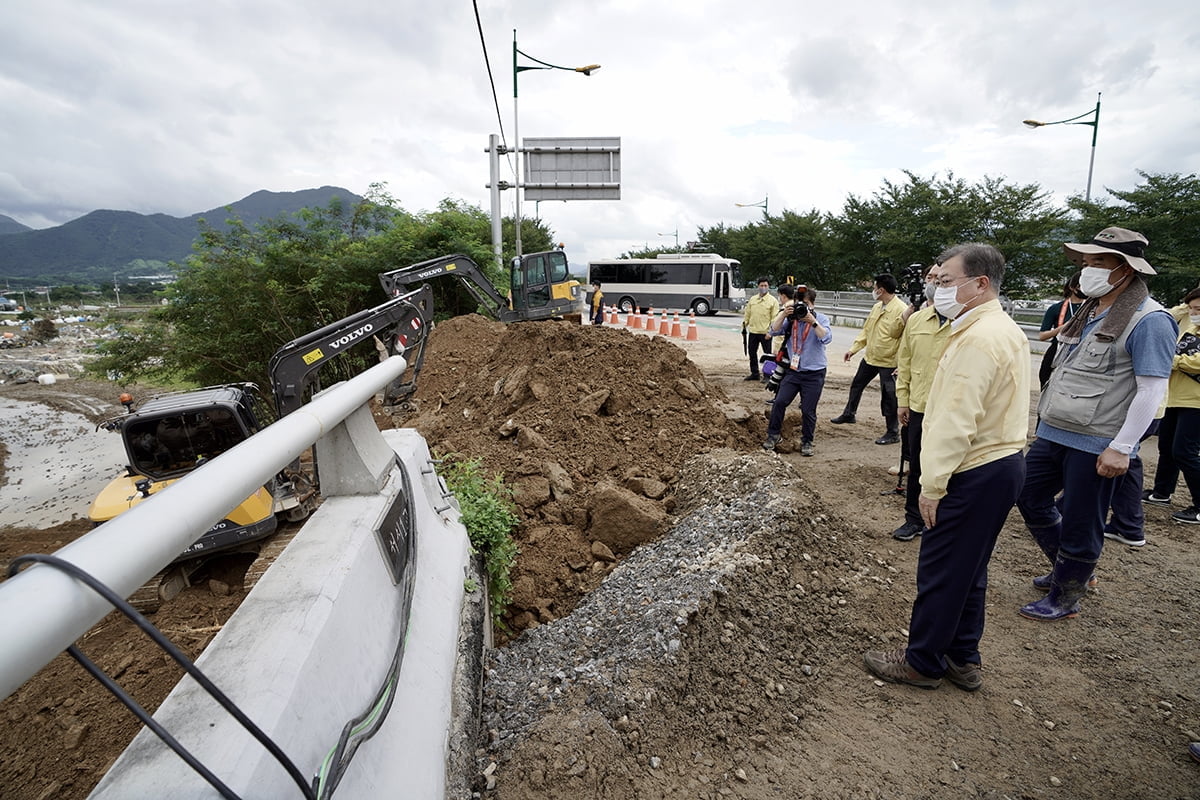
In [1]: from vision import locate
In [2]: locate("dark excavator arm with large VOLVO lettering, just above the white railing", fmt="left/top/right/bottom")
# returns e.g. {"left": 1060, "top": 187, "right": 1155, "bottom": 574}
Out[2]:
{"left": 269, "top": 287, "right": 433, "bottom": 417}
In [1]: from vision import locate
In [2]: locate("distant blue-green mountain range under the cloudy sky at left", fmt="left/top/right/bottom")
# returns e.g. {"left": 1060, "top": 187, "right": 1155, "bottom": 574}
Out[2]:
{"left": 0, "top": 186, "right": 362, "bottom": 283}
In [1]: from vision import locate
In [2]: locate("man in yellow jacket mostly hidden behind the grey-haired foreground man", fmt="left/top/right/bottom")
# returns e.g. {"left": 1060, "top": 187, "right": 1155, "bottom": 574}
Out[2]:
{"left": 892, "top": 264, "right": 950, "bottom": 542}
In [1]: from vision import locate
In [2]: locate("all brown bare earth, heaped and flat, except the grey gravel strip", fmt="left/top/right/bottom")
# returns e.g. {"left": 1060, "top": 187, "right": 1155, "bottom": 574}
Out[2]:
{"left": 0, "top": 318, "right": 1200, "bottom": 799}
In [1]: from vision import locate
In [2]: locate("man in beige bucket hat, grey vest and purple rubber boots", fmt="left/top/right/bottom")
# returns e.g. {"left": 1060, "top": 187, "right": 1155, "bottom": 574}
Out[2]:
{"left": 1016, "top": 228, "right": 1177, "bottom": 620}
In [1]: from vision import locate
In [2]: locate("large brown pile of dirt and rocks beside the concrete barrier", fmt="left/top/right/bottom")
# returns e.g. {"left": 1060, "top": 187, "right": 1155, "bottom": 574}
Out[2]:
{"left": 392, "top": 315, "right": 754, "bottom": 631}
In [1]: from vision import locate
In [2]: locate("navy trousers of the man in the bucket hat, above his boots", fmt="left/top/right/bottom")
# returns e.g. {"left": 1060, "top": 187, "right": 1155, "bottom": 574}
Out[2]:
{"left": 1016, "top": 439, "right": 1116, "bottom": 564}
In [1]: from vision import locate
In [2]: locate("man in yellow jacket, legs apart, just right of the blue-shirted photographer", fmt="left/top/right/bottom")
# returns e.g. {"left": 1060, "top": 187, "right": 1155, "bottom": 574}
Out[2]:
{"left": 830, "top": 272, "right": 907, "bottom": 445}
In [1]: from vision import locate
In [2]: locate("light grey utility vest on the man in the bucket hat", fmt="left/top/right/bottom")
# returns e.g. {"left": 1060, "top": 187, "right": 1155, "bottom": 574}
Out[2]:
{"left": 1038, "top": 299, "right": 1163, "bottom": 438}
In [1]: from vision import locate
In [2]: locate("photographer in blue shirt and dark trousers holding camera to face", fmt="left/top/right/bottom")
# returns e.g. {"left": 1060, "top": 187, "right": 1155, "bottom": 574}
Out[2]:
{"left": 762, "top": 285, "right": 833, "bottom": 456}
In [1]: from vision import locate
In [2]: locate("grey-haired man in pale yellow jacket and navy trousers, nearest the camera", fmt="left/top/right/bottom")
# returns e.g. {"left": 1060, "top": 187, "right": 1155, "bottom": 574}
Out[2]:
{"left": 863, "top": 243, "right": 1030, "bottom": 691}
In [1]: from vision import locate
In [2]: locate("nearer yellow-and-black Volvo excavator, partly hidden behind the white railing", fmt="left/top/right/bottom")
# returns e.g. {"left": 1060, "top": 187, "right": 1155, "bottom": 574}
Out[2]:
{"left": 88, "top": 287, "right": 433, "bottom": 610}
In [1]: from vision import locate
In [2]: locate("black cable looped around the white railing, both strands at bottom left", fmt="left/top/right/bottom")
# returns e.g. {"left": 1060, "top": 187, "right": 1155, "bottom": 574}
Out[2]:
{"left": 8, "top": 553, "right": 316, "bottom": 800}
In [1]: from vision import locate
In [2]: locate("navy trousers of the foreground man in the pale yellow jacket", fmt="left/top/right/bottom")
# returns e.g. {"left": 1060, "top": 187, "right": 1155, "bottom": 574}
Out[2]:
{"left": 907, "top": 453, "right": 1025, "bottom": 678}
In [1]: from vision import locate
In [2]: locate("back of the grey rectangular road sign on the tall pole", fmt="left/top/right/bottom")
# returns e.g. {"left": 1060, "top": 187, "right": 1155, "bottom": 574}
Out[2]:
{"left": 522, "top": 137, "right": 620, "bottom": 200}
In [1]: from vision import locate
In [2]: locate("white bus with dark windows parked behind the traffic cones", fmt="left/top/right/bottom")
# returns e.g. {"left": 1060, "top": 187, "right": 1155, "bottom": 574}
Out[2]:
{"left": 588, "top": 253, "right": 746, "bottom": 314}
